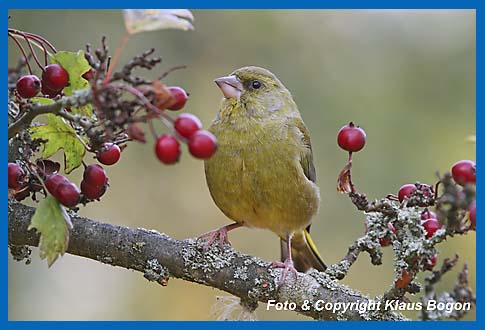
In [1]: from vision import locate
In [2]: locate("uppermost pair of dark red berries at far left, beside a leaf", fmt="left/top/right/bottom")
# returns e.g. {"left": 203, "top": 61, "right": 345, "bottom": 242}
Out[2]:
{"left": 16, "top": 64, "right": 69, "bottom": 99}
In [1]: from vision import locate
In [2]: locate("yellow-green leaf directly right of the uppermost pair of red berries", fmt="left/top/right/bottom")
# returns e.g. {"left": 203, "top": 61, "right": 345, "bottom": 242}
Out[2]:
{"left": 50, "top": 50, "right": 92, "bottom": 116}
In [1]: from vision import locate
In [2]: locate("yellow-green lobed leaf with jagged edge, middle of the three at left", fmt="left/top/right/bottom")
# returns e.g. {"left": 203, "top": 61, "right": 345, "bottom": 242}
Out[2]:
{"left": 30, "top": 113, "right": 86, "bottom": 174}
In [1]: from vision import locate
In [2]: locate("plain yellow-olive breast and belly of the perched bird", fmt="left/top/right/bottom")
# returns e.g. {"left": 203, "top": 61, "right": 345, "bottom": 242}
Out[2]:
{"left": 205, "top": 120, "right": 319, "bottom": 237}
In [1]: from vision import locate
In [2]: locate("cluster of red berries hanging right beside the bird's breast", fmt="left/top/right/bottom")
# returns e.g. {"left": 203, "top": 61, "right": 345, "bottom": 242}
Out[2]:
{"left": 155, "top": 86, "right": 217, "bottom": 164}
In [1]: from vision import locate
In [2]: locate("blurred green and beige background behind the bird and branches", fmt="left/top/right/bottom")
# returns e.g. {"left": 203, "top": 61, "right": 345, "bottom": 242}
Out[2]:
{"left": 8, "top": 10, "right": 476, "bottom": 320}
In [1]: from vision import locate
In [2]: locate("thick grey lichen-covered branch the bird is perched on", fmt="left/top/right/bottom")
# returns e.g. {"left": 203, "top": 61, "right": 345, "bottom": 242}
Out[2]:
{"left": 8, "top": 201, "right": 405, "bottom": 320}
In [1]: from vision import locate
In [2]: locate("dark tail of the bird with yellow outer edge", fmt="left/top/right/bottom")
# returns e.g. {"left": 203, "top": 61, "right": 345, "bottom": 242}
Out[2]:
{"left": 281, "top": 228, "right": 327, "bottom": 272}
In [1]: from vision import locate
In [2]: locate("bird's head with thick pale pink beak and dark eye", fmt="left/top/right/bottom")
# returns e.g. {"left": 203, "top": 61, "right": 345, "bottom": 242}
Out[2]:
{"left": 214, "top": 66, "right": 292, "bottom": 113}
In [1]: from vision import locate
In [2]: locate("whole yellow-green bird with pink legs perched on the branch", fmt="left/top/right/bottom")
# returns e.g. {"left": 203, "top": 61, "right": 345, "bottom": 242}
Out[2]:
{"left": 200, "top": 66, "right": 326, "bottom": 281}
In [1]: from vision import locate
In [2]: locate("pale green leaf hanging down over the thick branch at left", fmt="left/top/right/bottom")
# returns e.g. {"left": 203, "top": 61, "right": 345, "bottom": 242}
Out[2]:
{"left": 28, "top": 195, "right": 72, "bottom": 267}
